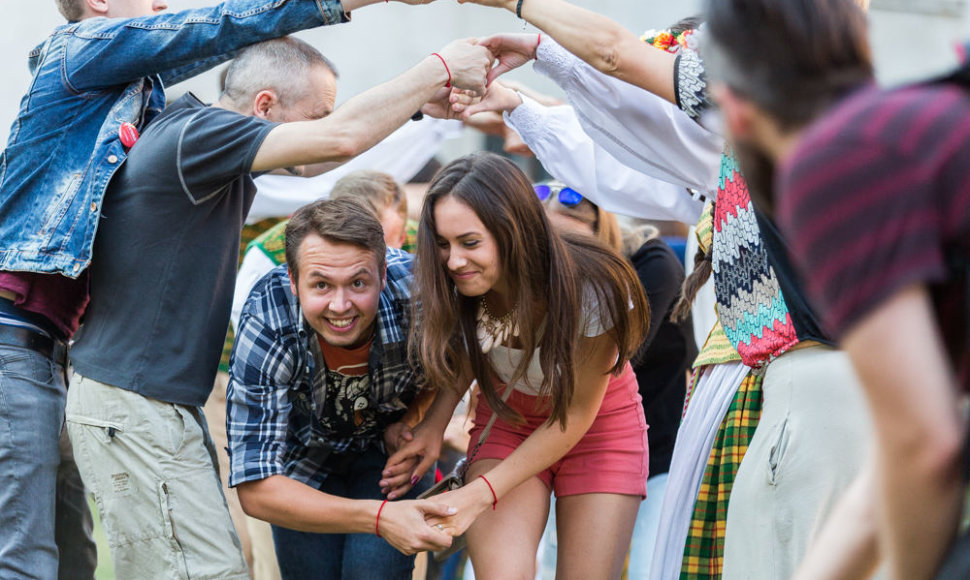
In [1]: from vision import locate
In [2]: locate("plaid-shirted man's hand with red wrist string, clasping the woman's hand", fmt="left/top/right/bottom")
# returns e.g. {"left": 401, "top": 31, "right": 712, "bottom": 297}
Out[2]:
{"left": 377, "top": 500, "right": 456, "bottom": 556}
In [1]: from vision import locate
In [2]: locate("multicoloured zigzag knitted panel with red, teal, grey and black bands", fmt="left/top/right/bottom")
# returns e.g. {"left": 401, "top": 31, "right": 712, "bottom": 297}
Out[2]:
{"left": 712, "top": 153, "right": 798, "bottom": 368}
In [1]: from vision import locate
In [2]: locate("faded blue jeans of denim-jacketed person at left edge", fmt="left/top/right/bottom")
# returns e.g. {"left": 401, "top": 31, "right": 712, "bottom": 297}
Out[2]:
{"left": 0, "top": 344, "right": 97, "bottom": 580}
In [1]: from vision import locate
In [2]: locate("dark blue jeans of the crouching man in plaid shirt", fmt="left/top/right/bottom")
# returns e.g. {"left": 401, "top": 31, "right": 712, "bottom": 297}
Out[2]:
{"left": 273, "top": 447, "right": 423, "bottom": 580}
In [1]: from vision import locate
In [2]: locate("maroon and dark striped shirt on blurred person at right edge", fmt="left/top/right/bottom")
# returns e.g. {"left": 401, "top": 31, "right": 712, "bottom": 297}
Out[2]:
{"left": 778, "top": 84, "right": 970, "bottom": 380}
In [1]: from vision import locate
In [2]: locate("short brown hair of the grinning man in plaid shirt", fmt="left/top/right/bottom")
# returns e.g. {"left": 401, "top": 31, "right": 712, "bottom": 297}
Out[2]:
{"left": 286, "top": 197, "right": 387, "bottom": 280}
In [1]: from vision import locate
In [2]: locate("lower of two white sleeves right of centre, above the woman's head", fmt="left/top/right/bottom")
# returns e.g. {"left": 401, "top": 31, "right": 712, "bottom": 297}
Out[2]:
{"left": 505, "top": 95, "right": 704, "bottom": 224}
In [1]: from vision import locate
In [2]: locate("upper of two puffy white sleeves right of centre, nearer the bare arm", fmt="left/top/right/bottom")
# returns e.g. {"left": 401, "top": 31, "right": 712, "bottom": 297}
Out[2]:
{"left": 534, "top": 36, "right": 724, "bottom": 193}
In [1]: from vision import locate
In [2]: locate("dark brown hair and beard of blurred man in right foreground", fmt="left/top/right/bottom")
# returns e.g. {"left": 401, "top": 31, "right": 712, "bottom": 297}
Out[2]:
{"left": 702, "top": 0, "right": 873, "bottom": 212}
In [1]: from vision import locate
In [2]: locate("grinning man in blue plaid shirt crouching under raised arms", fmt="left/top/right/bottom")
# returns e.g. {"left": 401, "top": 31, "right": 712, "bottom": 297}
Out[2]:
{"left": 227, "top": 198, "right": 447, "bottom": 579}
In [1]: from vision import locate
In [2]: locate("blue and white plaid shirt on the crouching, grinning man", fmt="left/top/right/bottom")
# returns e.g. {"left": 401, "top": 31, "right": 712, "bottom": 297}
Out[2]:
{"left": 226, "top": 249, "right": 420, "bottom": 489}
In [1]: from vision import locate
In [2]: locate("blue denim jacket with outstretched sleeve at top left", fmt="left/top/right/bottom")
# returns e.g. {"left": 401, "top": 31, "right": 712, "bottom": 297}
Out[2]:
{"left": 0, "top": 0, "right": 349, "bottom": 278}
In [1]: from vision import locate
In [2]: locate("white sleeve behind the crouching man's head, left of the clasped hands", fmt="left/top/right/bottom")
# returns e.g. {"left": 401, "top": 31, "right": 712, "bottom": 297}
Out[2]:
{"left": 246, "top": 117, "right": 463, "bottom": 224}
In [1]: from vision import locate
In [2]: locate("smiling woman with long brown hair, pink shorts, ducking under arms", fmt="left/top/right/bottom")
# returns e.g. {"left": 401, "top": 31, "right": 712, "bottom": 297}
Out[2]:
{"left": 382, "top": 153, "right": 649, "bottom": 580}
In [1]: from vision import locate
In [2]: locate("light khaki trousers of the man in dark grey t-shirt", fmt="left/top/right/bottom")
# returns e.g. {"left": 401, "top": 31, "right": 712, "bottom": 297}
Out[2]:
{"left": 67, "top": 374, "right": 249, "bottom": 580}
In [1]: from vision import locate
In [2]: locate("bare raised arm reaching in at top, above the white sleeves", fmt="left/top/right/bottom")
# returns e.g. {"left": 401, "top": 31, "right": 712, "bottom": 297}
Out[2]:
{"left": 458, "top": 0, "right": 676, "bottom": 103}
